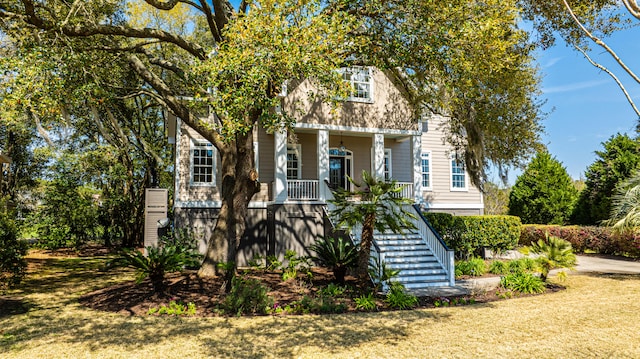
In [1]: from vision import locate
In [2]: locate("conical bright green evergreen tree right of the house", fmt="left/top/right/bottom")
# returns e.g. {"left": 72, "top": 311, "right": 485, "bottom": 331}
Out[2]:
{"left": 509, "top": 151, "right": 577, "bottom": 224}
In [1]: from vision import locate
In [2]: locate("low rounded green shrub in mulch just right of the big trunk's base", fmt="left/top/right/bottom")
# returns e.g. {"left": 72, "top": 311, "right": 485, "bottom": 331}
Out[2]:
{"left": 222, "top": 277, "right": 273, "bottom": 316}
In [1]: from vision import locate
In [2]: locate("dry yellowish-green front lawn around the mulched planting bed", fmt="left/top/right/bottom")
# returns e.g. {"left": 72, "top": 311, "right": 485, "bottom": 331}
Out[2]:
{"left": 0, "top": 252, "right": 640, "bottom": 358}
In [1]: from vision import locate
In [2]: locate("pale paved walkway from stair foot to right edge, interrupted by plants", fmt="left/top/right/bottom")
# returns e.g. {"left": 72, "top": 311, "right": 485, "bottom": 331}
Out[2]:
{"left": 412, "top": 255, "right": 640, "bottom": 297}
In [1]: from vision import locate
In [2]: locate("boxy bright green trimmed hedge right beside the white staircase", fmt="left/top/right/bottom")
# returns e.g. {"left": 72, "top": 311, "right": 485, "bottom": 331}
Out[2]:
{"left": 424, "top": 212, "right": 522, "bottom": 258}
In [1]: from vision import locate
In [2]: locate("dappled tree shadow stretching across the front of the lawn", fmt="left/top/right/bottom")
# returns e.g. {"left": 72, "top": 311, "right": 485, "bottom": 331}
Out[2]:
{"left": 0, "top": 309, "right": 450, "bottom": 358}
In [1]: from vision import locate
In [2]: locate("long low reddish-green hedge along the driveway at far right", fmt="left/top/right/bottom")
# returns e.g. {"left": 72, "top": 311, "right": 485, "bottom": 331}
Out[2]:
{"left": 518, "top": 224, "right": 640, "bottom": 258}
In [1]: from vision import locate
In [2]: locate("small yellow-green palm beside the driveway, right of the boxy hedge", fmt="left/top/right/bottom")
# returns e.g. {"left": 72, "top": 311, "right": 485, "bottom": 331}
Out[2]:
{"left": 525, "top": 233, "right": 576, "bottom": 282}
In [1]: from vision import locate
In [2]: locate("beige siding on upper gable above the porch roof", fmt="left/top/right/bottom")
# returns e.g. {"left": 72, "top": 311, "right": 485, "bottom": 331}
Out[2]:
{"left": 283, "top": 69, "right": 417, "bottom": 130}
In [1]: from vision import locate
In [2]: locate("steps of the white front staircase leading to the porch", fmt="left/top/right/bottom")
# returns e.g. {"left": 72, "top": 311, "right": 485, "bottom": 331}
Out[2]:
{"left": 374, "top": 233, "right": 450, "bottom": 290}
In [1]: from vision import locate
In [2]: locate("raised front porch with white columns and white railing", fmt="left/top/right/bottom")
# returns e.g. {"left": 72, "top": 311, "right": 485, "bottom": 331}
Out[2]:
{"left": 270, "top": 124, "right": 422, "bottom": 203}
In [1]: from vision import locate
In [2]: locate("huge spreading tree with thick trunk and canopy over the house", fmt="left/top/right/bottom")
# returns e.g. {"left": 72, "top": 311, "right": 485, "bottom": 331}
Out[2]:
{"left": 0, "top": 0, "right": 540, "bottom": 286}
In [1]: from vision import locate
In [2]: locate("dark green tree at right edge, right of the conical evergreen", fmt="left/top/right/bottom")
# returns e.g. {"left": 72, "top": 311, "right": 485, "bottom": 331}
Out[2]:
{"left": 571, "top": 133, "right": 640, "bottom": 225}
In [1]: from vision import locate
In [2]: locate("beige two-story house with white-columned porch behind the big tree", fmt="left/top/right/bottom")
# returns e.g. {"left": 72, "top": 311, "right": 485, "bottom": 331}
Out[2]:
{"left": 174, "top": 67, "right": 483, "bottom": 283}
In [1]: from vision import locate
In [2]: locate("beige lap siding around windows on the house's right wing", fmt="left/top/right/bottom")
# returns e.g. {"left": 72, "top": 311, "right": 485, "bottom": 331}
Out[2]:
{"left": 422, "top": 116, "right": 482, "bottom": 214}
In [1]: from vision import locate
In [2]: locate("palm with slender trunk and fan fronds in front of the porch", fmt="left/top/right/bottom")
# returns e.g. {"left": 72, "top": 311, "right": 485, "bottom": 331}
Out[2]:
{"left": 330, "top": 171, "right": 415, "bottom": 283}
